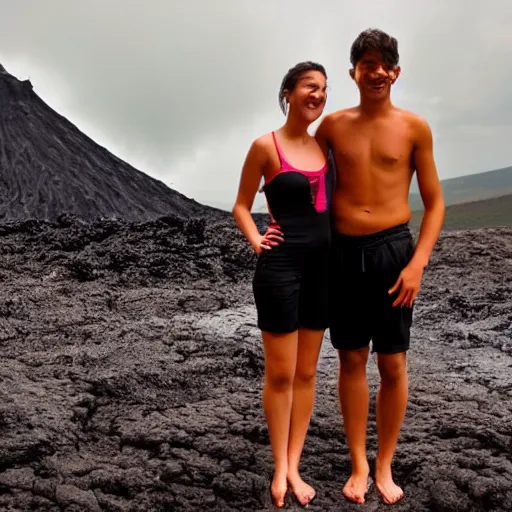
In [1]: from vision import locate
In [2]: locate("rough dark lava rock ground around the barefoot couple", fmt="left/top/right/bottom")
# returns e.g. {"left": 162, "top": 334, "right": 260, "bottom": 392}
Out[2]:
{"left": 0, "top": 216, "right": 512, "bottom": 512}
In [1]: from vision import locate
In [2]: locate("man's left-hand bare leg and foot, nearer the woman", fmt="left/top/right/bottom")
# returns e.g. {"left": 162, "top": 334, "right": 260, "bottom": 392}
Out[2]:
{"left": 338, "top": 347, "right": 370, "bottom": 503}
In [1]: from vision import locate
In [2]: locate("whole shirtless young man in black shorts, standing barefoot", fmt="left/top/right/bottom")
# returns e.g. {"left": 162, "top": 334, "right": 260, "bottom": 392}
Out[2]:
{"left": 316, "top": 30, "right": 445, "bottom": 504}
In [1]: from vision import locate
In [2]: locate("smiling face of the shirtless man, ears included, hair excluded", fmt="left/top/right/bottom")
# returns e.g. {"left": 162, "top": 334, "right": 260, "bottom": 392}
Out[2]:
{"left": 350, "top": 51, "right": 400, "bottom": 100}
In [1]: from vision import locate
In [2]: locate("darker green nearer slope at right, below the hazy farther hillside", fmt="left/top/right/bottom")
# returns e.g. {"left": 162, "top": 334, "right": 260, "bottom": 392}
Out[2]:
{"left": 411, "top": 194, "right": 512, "bottom": 229}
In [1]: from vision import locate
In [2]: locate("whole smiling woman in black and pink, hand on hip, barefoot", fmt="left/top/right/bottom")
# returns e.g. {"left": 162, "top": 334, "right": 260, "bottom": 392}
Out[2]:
{"left": 233, "top": 62, "right": 330, "bottom": 508}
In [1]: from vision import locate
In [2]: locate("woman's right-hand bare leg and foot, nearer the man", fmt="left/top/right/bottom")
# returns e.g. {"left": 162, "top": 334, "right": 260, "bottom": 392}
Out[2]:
{"left": 288, "top": 329, "right": 324, "bottom": 505}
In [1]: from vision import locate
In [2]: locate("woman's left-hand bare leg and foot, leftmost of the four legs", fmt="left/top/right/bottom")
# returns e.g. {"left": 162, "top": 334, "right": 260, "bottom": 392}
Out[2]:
{"left": 263, "top": 331, "right": 298, "bottom": 508}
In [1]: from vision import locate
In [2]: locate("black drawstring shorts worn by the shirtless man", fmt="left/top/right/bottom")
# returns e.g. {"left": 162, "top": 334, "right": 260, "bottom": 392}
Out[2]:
{"left": 329, "top": 224, "right": 414, "bottom": 354}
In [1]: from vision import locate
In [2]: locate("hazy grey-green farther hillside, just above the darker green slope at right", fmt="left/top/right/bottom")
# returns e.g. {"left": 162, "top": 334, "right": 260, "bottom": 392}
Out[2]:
{"left": 409, "top": 167, "right": 512, "bottom": 211}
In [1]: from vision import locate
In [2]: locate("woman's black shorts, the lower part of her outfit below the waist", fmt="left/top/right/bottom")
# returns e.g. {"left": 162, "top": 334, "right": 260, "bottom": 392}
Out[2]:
{"left": 253, "top": 244, "right": 329, "bottom": 334}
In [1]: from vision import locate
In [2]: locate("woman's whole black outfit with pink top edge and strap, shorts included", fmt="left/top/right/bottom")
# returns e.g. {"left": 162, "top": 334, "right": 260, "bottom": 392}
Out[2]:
{"left": 253, "top": 133, "right": 331, "bottom": 333}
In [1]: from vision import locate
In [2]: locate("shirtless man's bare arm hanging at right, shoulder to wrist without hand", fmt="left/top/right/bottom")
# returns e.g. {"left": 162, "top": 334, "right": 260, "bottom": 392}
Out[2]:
{"left": 411, "top": 119, "right": 445, "bottom": 267}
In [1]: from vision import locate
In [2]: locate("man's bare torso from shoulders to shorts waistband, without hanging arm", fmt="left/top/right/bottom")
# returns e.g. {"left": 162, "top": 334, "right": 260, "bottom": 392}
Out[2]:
{"left": 325, "top": 107, "right": 416, "bottom": 235}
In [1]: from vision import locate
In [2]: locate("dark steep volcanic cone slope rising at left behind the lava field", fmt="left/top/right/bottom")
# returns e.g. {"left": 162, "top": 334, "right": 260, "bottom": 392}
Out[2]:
{"left": 0, "top": 66, "right": 221, "bottom": 222}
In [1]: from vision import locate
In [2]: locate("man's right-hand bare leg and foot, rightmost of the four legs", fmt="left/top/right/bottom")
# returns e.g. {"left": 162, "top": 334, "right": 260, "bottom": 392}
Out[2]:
{"left": 375, "top": 352, "right": 408, "bottom": 504}
